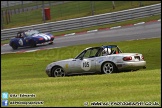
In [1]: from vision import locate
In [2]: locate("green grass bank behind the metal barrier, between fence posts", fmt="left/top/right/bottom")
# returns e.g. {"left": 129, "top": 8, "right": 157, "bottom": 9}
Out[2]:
{"left": 2, "top": 1, "right": 161, "bottom": 29}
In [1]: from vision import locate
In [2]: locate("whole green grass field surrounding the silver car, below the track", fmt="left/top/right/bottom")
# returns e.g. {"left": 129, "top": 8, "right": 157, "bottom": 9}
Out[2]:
{"left": 1, "top": 38, "right": 161, "bottom": 106}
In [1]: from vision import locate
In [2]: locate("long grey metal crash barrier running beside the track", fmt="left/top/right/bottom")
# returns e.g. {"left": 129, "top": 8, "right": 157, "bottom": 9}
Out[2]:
{"left": 1, "top": 3, "right": 161, "bottom": 40}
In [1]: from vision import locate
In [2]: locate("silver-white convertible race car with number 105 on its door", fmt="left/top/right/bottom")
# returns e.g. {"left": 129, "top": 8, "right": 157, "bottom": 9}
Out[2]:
{"left": 46, "top": 45, "right": 146, "bottom": 77}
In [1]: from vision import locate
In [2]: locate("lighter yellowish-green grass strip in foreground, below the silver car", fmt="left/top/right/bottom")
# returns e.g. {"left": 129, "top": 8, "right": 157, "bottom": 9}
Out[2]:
{"left": 2, "top": 69, "right": 161, "bottom": 107}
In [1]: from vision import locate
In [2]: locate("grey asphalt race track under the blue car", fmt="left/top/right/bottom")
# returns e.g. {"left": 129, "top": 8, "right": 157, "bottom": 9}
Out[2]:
{"left": 1, "top": 21, "right": 161, "bottom": 54}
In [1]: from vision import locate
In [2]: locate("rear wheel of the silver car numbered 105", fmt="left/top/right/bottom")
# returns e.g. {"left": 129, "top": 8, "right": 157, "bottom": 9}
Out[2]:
{"left": 101, "top": 62, "right": 117, "bottom": 74}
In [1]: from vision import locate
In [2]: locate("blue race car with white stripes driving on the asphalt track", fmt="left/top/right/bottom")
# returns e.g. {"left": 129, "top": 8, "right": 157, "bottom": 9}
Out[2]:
{"left": 9, "top": 30, "right": 54, "bottom": 50}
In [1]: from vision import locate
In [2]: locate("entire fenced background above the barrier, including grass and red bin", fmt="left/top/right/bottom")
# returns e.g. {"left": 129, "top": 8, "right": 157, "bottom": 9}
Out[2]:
{"left": 1, "top": 1, "right": 161, "bottom": 30}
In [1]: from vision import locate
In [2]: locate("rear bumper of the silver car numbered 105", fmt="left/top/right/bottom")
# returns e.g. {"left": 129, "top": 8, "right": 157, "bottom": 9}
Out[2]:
{"left": 116, "top": 61, "right": 146, "bottom": 70}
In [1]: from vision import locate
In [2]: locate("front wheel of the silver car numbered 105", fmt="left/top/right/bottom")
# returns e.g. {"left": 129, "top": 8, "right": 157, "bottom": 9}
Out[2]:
{"left": 51, "top": 67, "right": 65, "bottom": 77}
